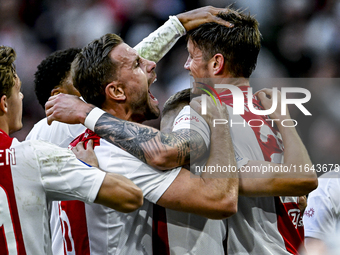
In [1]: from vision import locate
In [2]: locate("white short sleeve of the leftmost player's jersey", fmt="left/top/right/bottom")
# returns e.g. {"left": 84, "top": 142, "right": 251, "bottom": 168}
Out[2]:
{"left": 32, "top": 141, "right": 106, "bottom": 203}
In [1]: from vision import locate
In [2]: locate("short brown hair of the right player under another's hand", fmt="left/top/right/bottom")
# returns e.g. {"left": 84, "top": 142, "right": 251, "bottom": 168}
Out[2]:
{"left": 187, "top": 9, "right": 261, "bottom": 78}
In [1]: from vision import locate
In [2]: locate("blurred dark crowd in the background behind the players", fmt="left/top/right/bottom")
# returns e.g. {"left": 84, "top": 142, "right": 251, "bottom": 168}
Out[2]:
{"left": 0, "top": 0, "right": 340, "bottom": 170}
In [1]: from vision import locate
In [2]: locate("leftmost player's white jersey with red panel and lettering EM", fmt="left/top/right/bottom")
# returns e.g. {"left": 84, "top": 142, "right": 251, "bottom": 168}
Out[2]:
{"left": 0, "top": 130, "right": 105, "bottom": 255}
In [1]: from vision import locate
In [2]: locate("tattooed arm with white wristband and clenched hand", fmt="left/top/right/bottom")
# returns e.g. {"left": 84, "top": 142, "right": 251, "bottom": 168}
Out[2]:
{"left": 46, "top": 94, "right": 207, "bottom": 170}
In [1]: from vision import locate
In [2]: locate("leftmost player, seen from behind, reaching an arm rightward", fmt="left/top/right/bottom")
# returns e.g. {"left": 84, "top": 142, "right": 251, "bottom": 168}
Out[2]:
{"left": 0, "top": 46, "right": 143, "bottom": 255}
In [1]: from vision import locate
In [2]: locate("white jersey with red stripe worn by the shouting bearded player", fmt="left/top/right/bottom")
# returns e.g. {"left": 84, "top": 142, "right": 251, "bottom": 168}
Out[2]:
{"left": 51, "top": 129, "right": 181, "bottom": 255}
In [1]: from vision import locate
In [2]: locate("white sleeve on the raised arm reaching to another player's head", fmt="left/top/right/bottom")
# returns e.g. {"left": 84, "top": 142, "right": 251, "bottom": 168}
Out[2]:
{"left": 134, "top": 16, "right": 186, "bottom": 62}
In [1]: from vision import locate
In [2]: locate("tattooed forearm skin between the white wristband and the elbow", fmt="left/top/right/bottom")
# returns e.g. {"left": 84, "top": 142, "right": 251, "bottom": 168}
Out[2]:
{"left": 95, "top": 113, "right": 207, "bottom": 167}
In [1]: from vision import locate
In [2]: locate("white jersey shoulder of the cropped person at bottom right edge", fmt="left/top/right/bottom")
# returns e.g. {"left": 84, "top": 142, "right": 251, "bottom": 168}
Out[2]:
{"left": 303, "top": 171, "right": 340, "bottom": 241}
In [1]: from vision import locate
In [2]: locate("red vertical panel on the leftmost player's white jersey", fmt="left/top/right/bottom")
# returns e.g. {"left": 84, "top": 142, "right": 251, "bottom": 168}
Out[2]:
{"left": 0, "top": 130, "right": 26, "bottom": 255}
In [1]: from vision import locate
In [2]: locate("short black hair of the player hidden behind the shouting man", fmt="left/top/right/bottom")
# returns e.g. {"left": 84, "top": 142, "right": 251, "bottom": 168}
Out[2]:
{"left": 34, "top": 48, "right": 81, "bottom": 108}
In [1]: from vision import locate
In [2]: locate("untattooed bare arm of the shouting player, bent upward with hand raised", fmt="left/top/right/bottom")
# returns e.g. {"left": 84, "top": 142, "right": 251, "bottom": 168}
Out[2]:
{"left": 157, "top": 98, "right": 238, "bottom": 219}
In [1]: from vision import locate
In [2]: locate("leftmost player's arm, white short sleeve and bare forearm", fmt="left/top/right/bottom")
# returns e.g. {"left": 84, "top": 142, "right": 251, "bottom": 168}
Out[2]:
{"left": 36, "top": 141, "right": 143, "bottom": 212}
